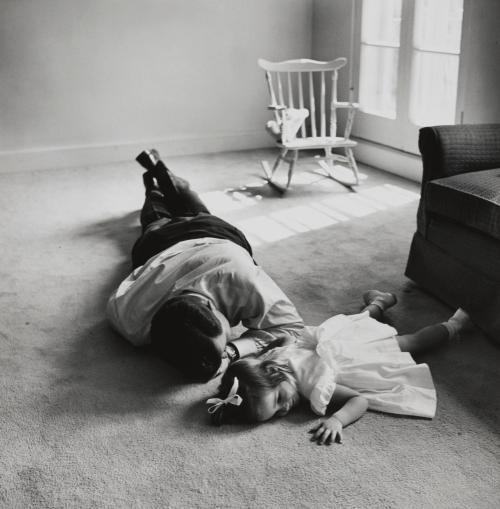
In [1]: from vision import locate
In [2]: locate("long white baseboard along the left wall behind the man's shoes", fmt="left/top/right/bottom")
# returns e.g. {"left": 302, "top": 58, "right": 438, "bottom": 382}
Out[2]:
{"left": 0, "top": 129, "right": 273, "bottom": 173}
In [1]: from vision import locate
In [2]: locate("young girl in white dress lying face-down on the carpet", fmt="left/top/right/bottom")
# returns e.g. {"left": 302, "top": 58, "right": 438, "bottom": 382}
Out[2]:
{"left": 207, "top": 290, "right": 470, "bottom": 445}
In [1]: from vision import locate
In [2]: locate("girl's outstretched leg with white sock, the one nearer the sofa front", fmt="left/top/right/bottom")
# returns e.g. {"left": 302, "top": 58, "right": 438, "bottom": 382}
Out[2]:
{"left": 396, "top": 309, "right": 472, "bottom": 354}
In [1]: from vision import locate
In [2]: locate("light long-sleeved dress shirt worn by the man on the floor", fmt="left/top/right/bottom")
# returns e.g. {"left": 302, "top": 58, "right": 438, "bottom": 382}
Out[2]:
{"left": 106, "top": 237, "right": 303, "bottom": 357}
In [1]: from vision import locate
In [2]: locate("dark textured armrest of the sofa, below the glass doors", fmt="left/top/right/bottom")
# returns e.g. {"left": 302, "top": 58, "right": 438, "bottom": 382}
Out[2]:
{"left": 418, "top": 124, "right": 500, "bottom": 185}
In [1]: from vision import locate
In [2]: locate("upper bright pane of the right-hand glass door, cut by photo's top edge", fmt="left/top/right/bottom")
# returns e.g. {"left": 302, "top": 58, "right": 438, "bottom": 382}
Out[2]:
{"left": 413, "top": 0, "right": 463, "bottom": 53}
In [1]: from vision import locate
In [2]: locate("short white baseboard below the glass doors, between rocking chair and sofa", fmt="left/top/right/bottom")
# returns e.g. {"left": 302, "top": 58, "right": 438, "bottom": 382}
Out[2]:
{"left": 354, "top": 138, "right": 422, "bottom": 182}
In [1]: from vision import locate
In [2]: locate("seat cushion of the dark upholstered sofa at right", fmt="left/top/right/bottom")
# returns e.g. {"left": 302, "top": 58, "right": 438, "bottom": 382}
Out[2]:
{"left": 426, "top": 169, "right": 500, "bottom": 240}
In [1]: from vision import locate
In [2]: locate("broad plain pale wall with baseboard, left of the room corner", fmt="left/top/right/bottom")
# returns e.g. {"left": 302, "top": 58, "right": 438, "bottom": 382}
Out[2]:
{"left": 0, "top": 0, "right": 312, "bottom": 171}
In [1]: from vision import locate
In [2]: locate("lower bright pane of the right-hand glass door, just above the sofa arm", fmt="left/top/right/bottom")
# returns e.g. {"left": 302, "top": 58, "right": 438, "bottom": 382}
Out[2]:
{"left": 410, "top": 50, "right": 459, "bottom": 126}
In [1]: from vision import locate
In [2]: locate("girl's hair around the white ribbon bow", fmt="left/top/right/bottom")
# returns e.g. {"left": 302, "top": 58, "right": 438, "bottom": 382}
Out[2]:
{"left": 211, "top": 357, "right": 296, "bottom": 426}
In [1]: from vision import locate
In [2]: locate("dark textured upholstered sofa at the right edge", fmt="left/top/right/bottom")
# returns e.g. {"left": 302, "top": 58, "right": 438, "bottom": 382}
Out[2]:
{"left": 405, "top": 124, "right": 500, "bottom": 341}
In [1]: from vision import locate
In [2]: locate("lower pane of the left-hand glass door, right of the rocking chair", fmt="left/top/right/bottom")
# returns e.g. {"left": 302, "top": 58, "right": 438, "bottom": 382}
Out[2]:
{"left": 359, "top": 44, "right": 399, "bottom": 118}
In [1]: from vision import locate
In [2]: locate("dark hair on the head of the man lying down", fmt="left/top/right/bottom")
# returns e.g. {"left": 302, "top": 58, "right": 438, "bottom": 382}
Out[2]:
{"left": 150, "top": 295, "right": 222, "bottom": 381}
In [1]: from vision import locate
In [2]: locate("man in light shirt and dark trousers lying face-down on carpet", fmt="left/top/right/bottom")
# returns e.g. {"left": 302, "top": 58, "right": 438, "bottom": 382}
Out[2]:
{"left": 107, "top": 150, "right": 303, "bottom": 381}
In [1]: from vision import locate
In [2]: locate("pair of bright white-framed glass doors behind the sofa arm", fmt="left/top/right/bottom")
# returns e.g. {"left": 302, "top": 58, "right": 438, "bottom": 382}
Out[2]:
{"left": 353, "top": 0, "right": 464, "bottom": 154}
